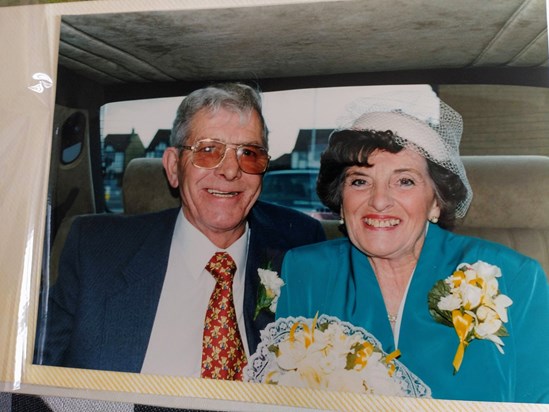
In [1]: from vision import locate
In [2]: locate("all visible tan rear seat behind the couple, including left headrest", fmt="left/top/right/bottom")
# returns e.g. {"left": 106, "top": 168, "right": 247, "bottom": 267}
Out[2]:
{"left": 123, "top": 156, "right": 549, "bottom": 276}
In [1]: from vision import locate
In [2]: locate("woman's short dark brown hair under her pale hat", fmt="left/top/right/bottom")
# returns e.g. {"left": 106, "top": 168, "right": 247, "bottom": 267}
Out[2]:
{"left": 316, "top": 130, "right": 467, "bottom": 229}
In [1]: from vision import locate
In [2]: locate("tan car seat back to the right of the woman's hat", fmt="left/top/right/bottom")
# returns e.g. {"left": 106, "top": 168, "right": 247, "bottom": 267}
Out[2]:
{"left": 456, "top": 156, "right": 549, "bottom": 278}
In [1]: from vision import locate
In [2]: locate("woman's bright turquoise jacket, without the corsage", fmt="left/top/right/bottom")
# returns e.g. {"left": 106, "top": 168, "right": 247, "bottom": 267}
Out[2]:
{"left": 276, "top": 224, "right": 549, "bottom": 403}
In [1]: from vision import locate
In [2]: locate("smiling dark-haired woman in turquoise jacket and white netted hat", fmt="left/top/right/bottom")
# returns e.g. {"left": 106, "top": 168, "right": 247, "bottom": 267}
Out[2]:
{"left": 277, "top": 102, "right": 549, "bottom": 402}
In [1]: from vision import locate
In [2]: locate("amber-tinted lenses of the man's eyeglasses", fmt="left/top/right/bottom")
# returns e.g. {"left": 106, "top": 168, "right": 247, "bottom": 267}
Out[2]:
{"left": 192, "top": 140, "right": 269, "bottom": 174}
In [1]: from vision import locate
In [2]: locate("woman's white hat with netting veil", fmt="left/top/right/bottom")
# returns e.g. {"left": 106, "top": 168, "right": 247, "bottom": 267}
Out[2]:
{"left": 337, "top": 98, "right": 473, "bottom": 218}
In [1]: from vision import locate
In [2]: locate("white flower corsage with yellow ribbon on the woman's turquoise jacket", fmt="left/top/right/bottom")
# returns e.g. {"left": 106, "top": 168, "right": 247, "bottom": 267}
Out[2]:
{"left": 428, "top": 261, "right": 513, "bottom": 374}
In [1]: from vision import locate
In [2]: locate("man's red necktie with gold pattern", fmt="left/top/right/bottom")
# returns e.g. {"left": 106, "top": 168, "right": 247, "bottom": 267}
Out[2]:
{"left": 201, "top": 252, "right": 247, "bottom": 380}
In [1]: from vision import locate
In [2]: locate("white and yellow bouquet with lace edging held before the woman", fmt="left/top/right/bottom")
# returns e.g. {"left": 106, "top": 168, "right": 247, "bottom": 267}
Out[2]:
{"left": 244, "top": 315, "right": 431, "bottom": 397}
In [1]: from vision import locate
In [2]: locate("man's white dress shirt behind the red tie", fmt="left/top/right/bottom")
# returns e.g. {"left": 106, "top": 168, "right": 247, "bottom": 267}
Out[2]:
{"left": 141, "top": 212, "right": 250, "bottom": 377}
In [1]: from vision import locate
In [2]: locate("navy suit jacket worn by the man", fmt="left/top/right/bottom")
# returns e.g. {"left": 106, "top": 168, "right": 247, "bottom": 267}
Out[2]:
{"left": 37, "top": 202, "right": 325, "bottom": 372}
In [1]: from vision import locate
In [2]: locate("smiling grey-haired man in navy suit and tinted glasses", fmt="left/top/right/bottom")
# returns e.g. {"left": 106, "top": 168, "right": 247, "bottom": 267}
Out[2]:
{"left": 44, "top": 83, "right": 324, "bottom": 379}
